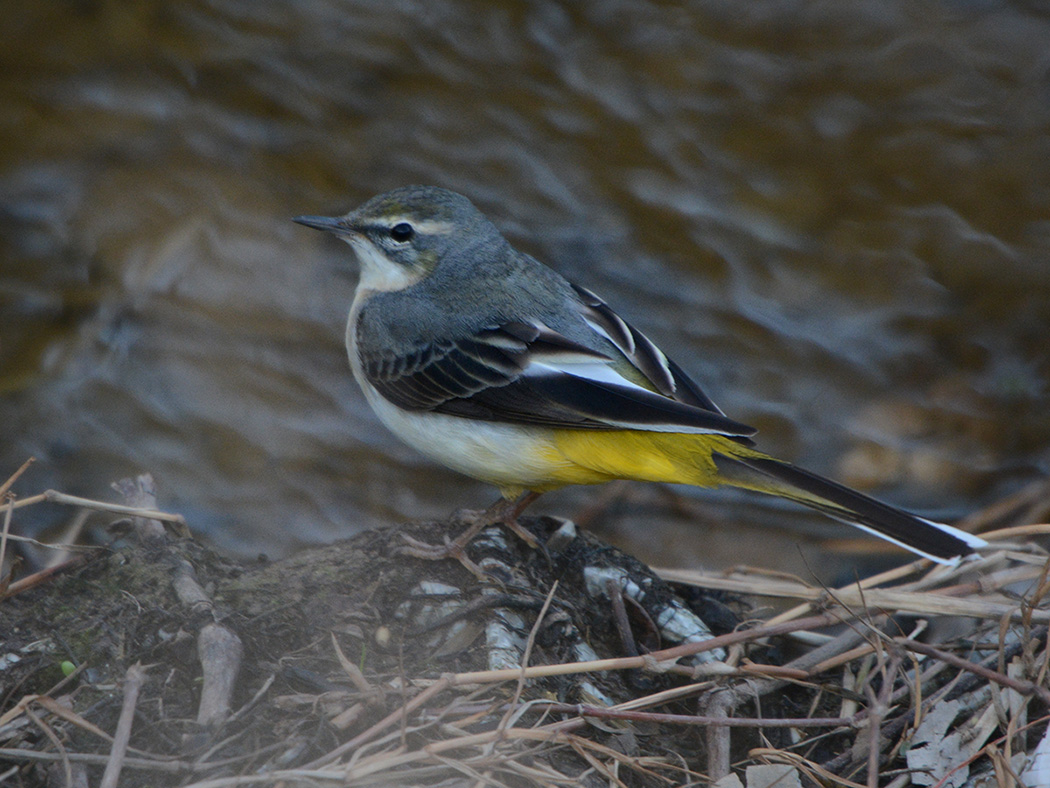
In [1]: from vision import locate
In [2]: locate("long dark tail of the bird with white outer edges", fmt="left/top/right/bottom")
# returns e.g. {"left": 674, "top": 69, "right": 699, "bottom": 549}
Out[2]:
{"left": 712, "top": 451, "right": 988, "bottom": 564}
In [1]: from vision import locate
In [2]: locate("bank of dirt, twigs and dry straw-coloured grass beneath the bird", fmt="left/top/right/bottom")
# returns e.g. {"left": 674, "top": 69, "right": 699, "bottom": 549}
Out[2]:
{"left": 0, "top": 462, "right": 1050, "bottom": 788}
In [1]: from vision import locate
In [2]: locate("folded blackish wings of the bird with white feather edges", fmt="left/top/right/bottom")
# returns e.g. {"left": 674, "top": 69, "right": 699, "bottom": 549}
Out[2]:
{"left": 361, "top": 310, "right": 754, "bottom": 438}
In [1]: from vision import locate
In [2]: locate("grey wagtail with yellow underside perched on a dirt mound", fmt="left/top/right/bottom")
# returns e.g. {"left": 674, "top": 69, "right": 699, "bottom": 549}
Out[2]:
{"left": 294, "top": 186, "right": 987, "bottom": 563}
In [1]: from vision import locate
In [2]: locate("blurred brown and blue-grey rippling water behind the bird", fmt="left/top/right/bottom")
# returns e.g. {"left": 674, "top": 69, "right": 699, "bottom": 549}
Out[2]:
{"left": 0, "top": 0, "right": 1050, "bottom": 565}
